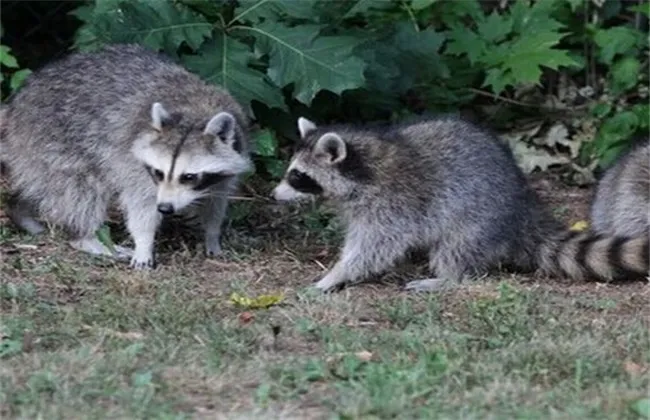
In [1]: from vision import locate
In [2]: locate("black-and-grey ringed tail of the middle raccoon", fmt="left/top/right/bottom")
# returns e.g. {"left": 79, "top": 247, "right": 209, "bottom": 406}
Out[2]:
{"left": 538, "top": 231, "right": 650, "bottom": 281}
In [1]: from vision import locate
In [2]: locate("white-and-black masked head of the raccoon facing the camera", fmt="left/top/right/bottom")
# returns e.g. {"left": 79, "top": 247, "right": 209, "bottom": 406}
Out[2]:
{"left": 132, "top": 103, "right": 252, "bottom": 214}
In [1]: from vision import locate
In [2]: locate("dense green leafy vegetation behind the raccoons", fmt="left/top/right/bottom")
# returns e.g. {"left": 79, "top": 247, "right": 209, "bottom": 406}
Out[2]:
{"left": 64, "top": 0, "right": 649, "bottom": 179}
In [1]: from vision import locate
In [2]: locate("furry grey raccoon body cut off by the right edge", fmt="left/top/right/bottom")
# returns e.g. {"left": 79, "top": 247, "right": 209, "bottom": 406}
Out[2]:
{"left": 591, "top": 139, "right": 650, "bottom": 240}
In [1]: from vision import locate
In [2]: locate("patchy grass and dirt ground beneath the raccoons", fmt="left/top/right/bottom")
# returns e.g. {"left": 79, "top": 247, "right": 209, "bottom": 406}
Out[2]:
{"left": 0, "top": 175, "right": 650, "bottom": 419}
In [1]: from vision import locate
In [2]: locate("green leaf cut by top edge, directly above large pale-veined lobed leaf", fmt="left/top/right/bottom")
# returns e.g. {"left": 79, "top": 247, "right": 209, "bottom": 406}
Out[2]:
{"left": 232, "top": 0, "right": 319, "bottom": 22}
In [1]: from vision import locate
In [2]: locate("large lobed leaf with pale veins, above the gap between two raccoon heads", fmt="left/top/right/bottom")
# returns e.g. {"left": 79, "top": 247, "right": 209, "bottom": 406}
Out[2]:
{"left": 242, "top": 22, "right": 366, "bottom": 105}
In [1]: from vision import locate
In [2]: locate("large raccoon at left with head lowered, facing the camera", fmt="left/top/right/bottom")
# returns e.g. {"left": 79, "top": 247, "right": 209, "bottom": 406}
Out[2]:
{"left": 0, "top": 45, "right": 251, "bottom": 268}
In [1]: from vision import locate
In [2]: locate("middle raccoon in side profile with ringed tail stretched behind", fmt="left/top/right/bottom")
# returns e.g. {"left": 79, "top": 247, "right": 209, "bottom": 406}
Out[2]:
{"left": 272, "top": 117, "right": 648, "bottom": 291}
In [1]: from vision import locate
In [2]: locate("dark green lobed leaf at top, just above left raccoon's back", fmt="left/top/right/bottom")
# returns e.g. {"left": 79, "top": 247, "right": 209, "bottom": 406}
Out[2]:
{"left": 74, "top": 0, "right": 212, "bottom": 54}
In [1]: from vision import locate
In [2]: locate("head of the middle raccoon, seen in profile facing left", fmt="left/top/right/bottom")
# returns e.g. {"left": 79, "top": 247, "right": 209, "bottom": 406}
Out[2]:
{"left": 271, "top": 117, "right": 370, "bottom": 201}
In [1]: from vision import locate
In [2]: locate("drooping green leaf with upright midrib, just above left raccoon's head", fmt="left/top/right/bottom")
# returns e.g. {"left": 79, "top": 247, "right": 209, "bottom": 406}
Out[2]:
{"left": 181, "top": 33, "right": 287, "bottom": 115}
